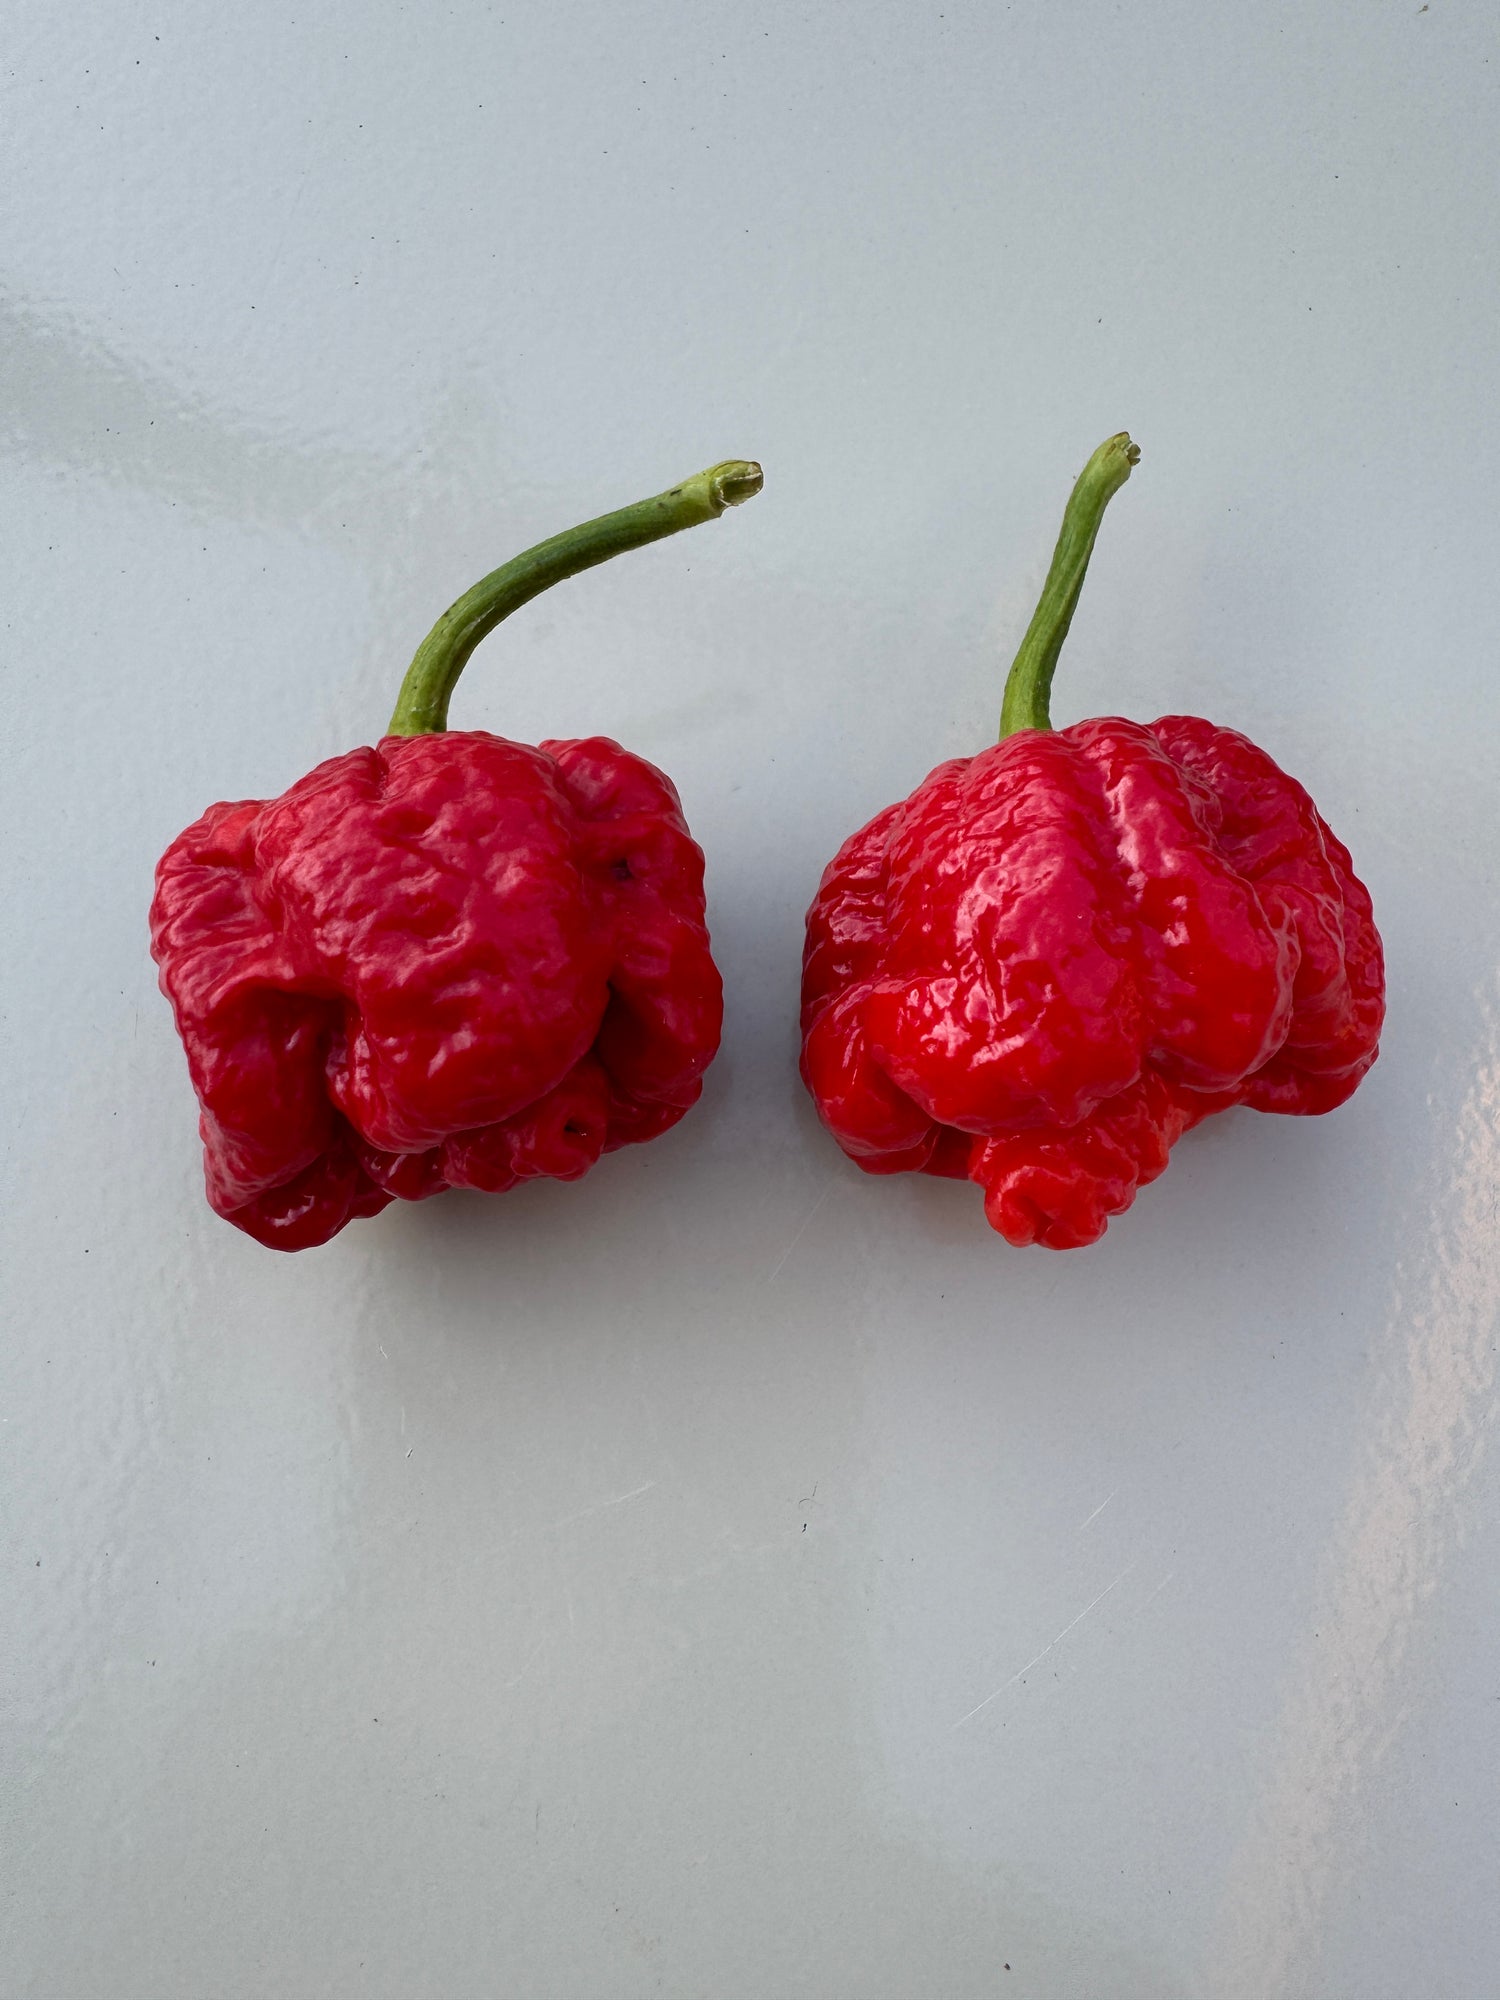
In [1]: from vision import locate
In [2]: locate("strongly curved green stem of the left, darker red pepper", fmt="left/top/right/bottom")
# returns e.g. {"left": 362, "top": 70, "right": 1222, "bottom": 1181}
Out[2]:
{"left": 388, "top": 458, "right": 762, "bottom": 736}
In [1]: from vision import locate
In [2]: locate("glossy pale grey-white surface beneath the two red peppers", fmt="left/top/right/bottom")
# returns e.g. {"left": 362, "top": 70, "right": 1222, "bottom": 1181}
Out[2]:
{"left": 0, "top": 0, "right": 1500, "bottom": 2000}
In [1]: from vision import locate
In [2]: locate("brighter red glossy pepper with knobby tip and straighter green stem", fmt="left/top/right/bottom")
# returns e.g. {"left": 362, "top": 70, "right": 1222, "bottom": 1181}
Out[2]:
{"left": 802, "top": 434, "right": 1384, "bottom": 1250}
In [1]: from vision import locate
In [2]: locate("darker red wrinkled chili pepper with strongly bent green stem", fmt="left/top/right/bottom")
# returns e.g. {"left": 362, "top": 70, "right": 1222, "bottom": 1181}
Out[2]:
{"left": 150, "top": 460, "right": 760, "bottom": 1250}
